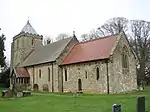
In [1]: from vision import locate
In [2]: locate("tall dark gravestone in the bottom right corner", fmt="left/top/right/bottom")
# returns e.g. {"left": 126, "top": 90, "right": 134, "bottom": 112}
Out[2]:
{"left": 136, "top": 96, "right": 145, "bottom": 112}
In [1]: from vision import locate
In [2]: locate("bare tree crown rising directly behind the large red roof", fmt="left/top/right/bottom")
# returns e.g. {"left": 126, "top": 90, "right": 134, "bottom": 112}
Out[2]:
{"left": 81, "top": 17, "right": 129, "bottom": 41}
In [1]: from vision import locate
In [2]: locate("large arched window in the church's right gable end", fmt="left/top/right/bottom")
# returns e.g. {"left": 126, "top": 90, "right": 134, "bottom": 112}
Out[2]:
{"left": 122, "top": 46, "right": 129, "bottom": 73}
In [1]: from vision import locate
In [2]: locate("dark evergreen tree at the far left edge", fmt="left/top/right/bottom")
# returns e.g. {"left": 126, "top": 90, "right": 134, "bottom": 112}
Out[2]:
{"left": 0, "top": 29, "right": 6, "bottom": 67}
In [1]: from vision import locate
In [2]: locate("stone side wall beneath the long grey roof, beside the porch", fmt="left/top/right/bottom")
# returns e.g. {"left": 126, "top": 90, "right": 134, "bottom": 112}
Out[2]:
{"left": 27, "top": 63, "right": 58, "bottom": 92}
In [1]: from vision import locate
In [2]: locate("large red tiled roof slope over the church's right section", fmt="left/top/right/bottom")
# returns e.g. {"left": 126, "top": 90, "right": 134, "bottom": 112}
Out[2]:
{"left": 63, "top": 35, "right": 118, "bottom": 64}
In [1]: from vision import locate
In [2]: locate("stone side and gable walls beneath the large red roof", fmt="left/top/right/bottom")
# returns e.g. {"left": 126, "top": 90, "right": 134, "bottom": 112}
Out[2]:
{"left": 62, "top": 35, "right": 137, "bottom": 93}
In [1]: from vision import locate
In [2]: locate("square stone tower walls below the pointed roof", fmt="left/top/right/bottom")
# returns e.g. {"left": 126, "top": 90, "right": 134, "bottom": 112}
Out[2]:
{"left": 11, "top": 34, "right": 42, "bottom": 67}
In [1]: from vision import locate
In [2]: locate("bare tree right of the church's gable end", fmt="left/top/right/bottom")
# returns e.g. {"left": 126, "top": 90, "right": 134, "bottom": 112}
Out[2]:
{"left": 130, "top": 20, "right": 150, "bottom": 83}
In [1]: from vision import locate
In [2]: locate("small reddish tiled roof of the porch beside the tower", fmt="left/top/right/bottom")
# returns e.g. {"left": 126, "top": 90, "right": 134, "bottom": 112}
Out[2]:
{"left": 15, "top": 67, "right": 29, "bottom": 77}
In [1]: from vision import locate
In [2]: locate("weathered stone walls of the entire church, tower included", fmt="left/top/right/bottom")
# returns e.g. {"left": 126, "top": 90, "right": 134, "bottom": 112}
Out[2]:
{"left": 11, "top": 25, "right": 137, "bottom": 94}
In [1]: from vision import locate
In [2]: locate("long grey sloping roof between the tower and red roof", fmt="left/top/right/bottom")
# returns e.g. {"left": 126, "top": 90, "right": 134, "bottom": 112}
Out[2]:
{"left": 22, "top": 37, "right": 73, "bottom": 67}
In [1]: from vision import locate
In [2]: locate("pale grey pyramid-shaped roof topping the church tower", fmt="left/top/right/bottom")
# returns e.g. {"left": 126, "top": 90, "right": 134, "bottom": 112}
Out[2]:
{"left": 21, "top": 20, "right": 38, "bottom": 35}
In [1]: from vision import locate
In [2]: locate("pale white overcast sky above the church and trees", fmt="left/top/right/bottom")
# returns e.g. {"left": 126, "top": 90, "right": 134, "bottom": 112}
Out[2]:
{"left": 0, "top": 0, "right": 150, "bottom": 65}
